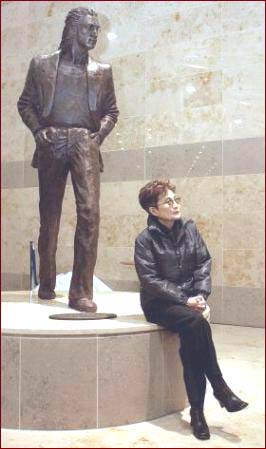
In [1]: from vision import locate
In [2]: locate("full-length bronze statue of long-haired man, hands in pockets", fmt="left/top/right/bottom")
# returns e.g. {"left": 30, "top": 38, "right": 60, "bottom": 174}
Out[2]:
{"left": 18, "top": 7, "right": 119, "bottom": 312}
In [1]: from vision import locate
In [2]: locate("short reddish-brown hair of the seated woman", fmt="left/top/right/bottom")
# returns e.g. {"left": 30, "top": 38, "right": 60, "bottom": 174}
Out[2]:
{"left": 139, "top": 179, "right": 176, "bottom": 212}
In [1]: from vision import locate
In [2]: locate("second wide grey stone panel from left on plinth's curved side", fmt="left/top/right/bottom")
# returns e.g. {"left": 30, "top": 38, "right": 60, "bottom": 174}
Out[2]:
{"left": 99, "top": 333, "right": 163, "bottom": 427}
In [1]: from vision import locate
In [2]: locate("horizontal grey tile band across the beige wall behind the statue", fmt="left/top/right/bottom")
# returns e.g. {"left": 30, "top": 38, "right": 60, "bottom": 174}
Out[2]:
{"left": 2, "top": 137, "right": 264, "bottom": 189}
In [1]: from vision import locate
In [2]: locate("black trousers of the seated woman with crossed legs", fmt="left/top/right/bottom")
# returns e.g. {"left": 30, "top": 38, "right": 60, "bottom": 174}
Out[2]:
{"left": 145, "top": 300, "right": 222, "bottom": 406}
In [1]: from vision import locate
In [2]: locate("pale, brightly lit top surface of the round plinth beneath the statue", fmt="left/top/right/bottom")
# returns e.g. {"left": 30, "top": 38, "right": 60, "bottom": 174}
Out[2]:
{"left": 1, "top": 291, "right": 210, "bottom": 335}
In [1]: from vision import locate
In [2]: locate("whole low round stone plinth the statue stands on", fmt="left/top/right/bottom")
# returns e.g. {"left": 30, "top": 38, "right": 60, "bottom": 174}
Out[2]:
{"left": 2, "top": 292, "right": 210, "bottom": 430}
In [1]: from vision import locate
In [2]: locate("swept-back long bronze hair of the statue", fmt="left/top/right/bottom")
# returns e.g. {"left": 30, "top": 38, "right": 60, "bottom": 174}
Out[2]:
{"left": 59, "top": 7, "right": 98, "bottom": 53}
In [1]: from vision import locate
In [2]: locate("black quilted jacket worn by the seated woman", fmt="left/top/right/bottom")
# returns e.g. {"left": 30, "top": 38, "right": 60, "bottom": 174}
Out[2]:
{"left": 135, "top": 215, "right": 211, "bottom": 313}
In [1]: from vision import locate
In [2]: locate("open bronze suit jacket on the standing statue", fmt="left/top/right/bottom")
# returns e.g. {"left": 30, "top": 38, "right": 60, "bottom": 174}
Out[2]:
{"left": 17, "top": 50, "right": 119, "bottom": 168}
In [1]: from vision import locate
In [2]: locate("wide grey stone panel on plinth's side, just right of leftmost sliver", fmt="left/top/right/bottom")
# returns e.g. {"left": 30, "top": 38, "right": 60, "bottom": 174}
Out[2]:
{"left": 21, "top": 338, "right": 97, "bottom": 430}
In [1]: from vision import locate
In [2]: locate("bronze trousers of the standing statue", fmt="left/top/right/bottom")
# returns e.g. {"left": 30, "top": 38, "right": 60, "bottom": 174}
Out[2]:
{"left": 38, "top": 128, "right": 100, "bottom": 300}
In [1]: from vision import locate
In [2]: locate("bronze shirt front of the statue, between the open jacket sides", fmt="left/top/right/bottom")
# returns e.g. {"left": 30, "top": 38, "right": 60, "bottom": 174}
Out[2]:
{"left": 46, "top": 62, "right": 93, "bottom": 129}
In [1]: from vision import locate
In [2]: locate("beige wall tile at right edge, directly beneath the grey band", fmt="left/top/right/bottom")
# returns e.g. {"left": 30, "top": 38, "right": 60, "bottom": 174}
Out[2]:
{"left": 223, "top": 174, "right": 265, "bottom": 213}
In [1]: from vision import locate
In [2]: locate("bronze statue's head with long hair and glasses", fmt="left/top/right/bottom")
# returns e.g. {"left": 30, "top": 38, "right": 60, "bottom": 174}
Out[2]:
{"left": 59, "top": 7, "right": 100, "bottom": 52}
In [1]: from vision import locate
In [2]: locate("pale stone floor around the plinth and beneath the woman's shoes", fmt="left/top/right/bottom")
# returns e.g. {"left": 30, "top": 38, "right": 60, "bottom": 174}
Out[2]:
{"left": 2, "top": 325, "right": 265, "bottom": 448}
